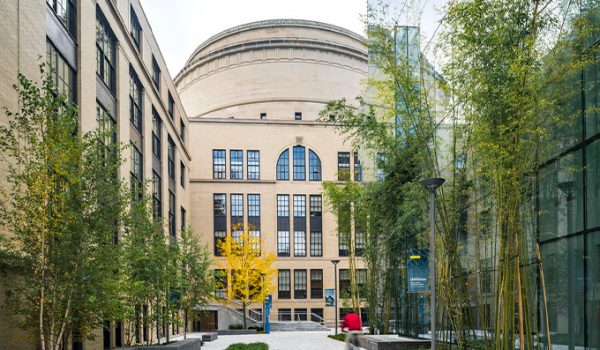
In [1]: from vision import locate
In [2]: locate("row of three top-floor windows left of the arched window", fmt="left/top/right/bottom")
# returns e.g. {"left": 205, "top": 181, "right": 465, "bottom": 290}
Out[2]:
{"left": 213, "top": 149, "right": 260, "bottom": 180}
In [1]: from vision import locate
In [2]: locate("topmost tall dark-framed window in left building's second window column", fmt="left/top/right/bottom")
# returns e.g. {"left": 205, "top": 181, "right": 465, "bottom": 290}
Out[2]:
{"left": 96, "top": 8, "right": 116, "bottom": 95}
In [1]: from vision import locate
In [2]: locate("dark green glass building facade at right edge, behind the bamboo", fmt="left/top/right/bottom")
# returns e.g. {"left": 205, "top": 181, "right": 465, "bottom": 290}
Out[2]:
{"left": 537, "top": 7, "right": 600, "bottom": 349}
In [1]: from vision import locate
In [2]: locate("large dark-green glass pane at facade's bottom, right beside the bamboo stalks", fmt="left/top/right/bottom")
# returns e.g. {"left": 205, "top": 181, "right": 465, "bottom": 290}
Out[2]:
{"left": 540, "top": 236, "right": 585, "bottom": 349}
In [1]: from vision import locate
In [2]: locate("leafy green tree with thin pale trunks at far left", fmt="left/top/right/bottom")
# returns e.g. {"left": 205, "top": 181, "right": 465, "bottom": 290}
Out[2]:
{"left": 0, "top": 67, "right": 124, "bottom": 349}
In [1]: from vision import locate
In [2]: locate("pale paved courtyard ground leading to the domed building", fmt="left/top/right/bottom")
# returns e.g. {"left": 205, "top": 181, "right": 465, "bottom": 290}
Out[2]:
{"left": 175, "top": 332, "right": 364, "bottom": 350}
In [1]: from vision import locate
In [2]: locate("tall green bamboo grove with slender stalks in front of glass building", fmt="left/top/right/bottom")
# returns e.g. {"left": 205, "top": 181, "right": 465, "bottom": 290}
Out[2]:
{"left": 321, "top": 0, "right": 598, "bottom": 349}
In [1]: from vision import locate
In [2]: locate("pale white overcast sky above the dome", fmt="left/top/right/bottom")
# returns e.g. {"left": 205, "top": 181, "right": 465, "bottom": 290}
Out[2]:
{"left": 141, "top": 0, "right": 447, "bottom": 76}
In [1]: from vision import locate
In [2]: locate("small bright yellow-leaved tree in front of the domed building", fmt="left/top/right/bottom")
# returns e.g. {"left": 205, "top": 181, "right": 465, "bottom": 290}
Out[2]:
{"left": 217, "top": 224, "right": 275, "bottom": 329}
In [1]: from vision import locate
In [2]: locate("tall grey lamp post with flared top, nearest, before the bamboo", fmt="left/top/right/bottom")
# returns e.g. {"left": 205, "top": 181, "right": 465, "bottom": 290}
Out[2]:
{"left": 421, "top": 177, "right": 446, "bottom": 350}
